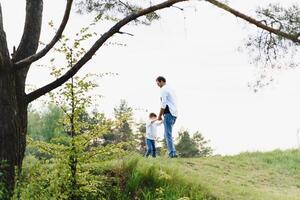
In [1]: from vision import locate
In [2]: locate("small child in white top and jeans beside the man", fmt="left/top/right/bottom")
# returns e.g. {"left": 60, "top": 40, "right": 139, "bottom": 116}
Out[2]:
{"left": 145, "top": 113, "right": 162, "bottom": 157}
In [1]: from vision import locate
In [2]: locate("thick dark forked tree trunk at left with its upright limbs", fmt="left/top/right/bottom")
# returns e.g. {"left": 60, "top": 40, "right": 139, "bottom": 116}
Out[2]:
{"left": 0, "top": 0, "right": 43, "bottom": 199}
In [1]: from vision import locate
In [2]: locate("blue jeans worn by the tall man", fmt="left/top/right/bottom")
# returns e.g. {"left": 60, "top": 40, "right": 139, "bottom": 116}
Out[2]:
{"left": 164, "top": 113, "right": 176, "bottom": 157}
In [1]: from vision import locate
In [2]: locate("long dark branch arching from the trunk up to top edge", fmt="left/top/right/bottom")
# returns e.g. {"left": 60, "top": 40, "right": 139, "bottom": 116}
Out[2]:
{"left": 27, "top": 0, "right": 188, "bottom": 103}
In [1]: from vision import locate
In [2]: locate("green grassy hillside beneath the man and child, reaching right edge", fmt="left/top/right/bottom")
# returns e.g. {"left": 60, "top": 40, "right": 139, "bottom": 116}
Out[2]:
{"left": 109, "top": 150, "right": 300, "bottom": 200}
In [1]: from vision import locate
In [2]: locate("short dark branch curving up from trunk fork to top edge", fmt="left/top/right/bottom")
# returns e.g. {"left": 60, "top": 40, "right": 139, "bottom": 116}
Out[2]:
{"left": 15, "top": 0, "right": 73, "bottom": 69}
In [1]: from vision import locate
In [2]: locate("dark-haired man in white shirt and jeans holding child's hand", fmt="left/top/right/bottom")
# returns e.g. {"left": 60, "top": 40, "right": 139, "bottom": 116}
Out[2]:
{"left": 156, "top": 76, "right": 177, "bottom": 158}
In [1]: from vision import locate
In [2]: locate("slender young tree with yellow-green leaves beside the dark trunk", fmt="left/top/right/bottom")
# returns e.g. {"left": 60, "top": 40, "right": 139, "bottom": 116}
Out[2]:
{"left": 50, "top": 25, "right": 106, "bottom": 200}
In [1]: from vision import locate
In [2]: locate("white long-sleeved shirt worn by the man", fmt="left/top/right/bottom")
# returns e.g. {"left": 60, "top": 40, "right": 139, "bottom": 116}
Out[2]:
{"left": 160, "top": 84, "right": 178, "bottom": 117}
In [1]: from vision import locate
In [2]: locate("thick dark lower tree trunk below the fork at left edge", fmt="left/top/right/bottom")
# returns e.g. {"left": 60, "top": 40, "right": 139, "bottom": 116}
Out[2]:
{"left": 0, "top": 71, "right": 27, "bottom": 199}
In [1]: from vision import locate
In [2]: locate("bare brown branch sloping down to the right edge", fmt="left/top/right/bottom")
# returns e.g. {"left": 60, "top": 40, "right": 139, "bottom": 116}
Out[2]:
{"left": 205, "top": 0, "right": 300, "bottom": 44}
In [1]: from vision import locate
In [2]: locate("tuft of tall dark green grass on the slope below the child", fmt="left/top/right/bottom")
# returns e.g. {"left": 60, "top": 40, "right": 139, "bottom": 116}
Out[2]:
{"left": 104, "top": 155, "right": 215, "bottom": 200}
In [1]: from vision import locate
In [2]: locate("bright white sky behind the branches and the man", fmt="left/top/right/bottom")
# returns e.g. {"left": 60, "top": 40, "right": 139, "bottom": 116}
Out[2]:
{"left": 1, "top": 0, "right": 300, "bottom": 154}
